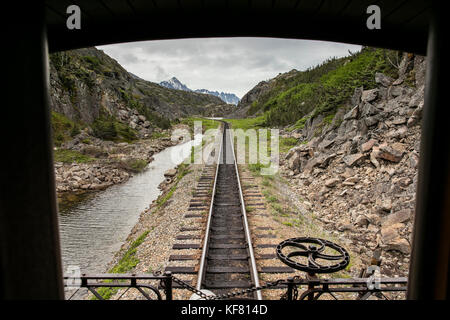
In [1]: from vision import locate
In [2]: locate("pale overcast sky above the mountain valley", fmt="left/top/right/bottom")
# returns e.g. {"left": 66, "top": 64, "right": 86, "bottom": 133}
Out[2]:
{"left": 97, "top": 38, "right": 361, "bottom": 98}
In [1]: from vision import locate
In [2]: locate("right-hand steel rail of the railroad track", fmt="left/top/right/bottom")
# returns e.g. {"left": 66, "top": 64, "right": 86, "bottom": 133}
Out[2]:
{"left": 230, "top": 127, "right": 262, "bottom": 300}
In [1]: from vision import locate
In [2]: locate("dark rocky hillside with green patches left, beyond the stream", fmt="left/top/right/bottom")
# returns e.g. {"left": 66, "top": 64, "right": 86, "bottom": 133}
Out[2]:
{"left": 50, "top": 48, "right": 229, "bottom": 145}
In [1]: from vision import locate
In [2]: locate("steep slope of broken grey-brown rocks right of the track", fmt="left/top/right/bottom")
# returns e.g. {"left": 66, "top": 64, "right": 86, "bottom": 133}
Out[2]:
{"left": 281, "top": 54, "right": 425, "bottom": 276}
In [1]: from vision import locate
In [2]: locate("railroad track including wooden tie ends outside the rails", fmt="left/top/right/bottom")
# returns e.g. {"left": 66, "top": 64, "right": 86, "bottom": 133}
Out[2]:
{"left": 166, "top": 122, "right": 293, "bottom": 300}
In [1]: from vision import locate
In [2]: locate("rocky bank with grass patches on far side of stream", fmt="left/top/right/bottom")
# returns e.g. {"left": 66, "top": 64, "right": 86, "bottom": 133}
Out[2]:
{"left": 54, "top": 125, "right": 188, "bottom": 195}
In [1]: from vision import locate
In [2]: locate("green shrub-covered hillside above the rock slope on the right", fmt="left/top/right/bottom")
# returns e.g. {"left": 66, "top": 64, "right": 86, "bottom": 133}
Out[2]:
{"left": 230, "top": 48, "right": 411, "bottom": 127}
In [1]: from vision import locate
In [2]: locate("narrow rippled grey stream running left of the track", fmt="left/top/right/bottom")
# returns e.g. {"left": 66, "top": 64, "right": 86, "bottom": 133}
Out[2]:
{"left": 59, "top": 137, "right": 201, "bottom": 273}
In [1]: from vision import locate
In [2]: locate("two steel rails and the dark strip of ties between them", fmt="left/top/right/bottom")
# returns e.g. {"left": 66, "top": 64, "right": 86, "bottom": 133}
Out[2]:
{"left": 197, "top": 123, "right": 261, "bottom": 300}
